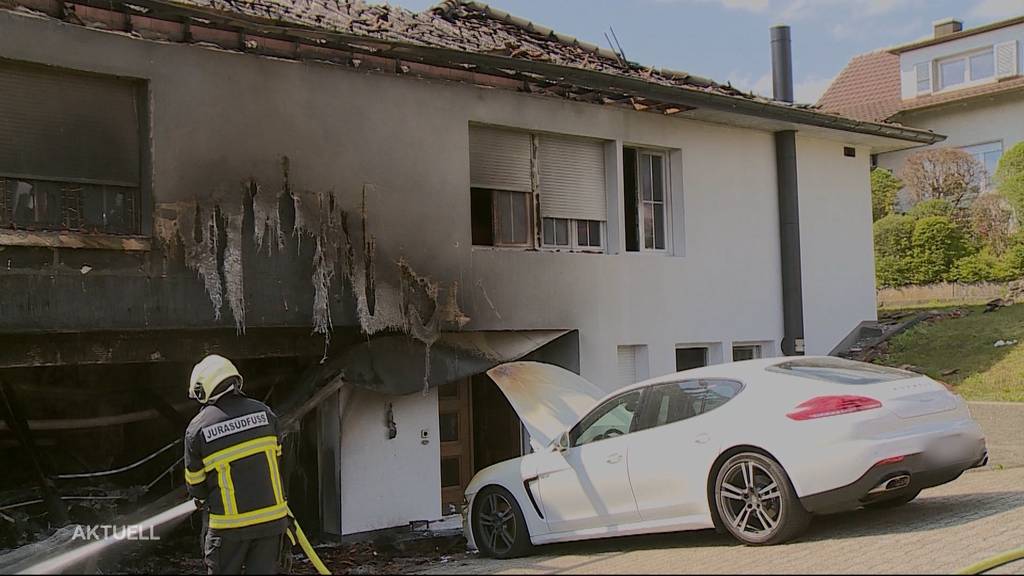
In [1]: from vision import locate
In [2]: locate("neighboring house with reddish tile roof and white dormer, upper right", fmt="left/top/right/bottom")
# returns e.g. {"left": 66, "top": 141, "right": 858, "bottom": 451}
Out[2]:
{"left": 818, "top": 14, "right": 1024, "bottom": 196}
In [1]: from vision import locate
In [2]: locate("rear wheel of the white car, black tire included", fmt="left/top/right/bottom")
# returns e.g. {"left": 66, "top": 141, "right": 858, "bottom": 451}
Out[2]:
{"left": 714, "top": 452, "right": 811, "bottom": 546}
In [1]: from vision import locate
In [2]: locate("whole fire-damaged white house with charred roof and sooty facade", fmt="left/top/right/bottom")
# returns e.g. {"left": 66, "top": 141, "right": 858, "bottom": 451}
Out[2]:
{"left": 0, "top": 0, "right": 942, "bottom": 534}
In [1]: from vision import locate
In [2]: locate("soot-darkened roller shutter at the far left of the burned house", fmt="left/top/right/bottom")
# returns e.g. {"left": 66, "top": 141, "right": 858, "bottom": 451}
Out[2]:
{"left": 0, "top": 59, "right": 139, "bottom": 186}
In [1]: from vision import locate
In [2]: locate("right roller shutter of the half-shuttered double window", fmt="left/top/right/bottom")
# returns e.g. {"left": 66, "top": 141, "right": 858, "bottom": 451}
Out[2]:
{"left": 537, "top": 134, "right": 608, "bottom": 220}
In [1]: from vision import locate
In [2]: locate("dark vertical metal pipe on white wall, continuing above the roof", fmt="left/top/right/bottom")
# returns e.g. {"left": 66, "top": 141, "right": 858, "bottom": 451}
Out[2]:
{"left": 771, "top": 26, "right": 804, "bottom": 356}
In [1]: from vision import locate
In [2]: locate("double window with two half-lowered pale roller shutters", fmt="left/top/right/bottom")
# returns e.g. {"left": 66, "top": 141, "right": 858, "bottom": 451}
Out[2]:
{"left": 469, "top": 126, "right": 607, "bottom": 251}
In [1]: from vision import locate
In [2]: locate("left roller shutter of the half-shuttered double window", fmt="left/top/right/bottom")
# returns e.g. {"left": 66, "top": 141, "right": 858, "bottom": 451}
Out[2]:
{"left": 469, "top": 126, "right": 532, "bottom": 192}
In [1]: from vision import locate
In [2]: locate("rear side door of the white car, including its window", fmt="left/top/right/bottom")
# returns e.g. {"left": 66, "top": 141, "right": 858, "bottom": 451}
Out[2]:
{"left": 629, "top": 380, "right": 742, "bottom": 524}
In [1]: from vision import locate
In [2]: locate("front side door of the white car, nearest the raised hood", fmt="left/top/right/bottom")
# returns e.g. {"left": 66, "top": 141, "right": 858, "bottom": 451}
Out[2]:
{"left": 538, "top": 390, "right": 642, "bottom": 532}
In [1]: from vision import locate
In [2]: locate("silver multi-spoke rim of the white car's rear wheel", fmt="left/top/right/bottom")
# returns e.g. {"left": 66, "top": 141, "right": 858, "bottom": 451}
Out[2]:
{"left": 718, "top": 459, "right": 782, "bottom": 540}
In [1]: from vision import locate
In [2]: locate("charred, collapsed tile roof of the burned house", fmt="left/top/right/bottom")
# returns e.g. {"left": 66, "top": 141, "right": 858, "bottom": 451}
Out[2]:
{"left": 15, "top": 0, "right": 944, "bottom": 143}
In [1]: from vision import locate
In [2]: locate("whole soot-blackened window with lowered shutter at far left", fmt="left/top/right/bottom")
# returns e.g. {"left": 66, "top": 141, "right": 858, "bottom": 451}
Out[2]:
{"left": 0, "top": 60, "right": 141, "bottom": 234}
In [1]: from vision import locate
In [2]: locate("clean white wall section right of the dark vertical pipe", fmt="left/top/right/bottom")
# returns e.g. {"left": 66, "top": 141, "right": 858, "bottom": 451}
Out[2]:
{"left": 797, "top": 136, "right": 877, "bottom": 355}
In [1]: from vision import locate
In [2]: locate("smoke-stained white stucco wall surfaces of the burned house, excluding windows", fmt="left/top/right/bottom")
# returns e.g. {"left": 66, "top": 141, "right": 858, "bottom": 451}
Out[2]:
{"left": 0, "top": 8, "right": 888, "bottom": 533}
